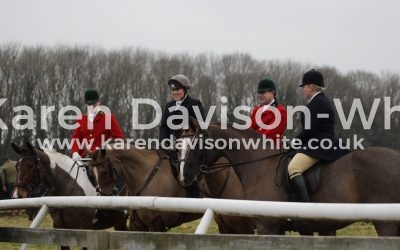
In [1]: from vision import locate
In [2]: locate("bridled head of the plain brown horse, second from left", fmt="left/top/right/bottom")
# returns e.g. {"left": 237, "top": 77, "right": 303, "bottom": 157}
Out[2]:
{"left": 88, "top": 149, "right": 119, "bottom": 196}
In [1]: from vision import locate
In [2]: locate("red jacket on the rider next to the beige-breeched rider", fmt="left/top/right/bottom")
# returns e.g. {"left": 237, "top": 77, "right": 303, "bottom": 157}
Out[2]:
{"left": 250, "top": 102, "right": 287, "bottom": 145}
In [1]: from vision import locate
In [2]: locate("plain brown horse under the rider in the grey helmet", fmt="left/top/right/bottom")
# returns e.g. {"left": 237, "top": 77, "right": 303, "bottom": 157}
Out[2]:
{"left": 88, "top": 144, "right": 254, "bottom": 234}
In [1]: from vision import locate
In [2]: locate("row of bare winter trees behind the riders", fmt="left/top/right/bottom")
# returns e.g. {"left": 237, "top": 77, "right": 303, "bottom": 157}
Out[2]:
{"left": 0, "top": 43, "right": 400, "bottom": 162}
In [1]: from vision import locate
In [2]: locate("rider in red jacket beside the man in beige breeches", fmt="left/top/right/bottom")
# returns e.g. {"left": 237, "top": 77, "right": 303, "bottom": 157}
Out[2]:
{"left": 250, "top": 79, "right": 287, "bottom": 146}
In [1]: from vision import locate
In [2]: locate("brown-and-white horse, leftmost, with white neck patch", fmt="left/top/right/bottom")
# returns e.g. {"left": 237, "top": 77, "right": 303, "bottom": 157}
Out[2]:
{"left": 12, "top": 142, "right": 128, "bottom": 249}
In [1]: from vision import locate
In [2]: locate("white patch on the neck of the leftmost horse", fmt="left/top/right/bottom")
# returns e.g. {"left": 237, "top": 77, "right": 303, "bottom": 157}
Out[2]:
{"left": 45, "top": 150, "right": 97, "bottom": 196}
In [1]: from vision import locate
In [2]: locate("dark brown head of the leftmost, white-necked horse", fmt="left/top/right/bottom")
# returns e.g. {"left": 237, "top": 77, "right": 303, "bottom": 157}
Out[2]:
{"left": 11, "top": 142, "right": 54, "bottom": 198}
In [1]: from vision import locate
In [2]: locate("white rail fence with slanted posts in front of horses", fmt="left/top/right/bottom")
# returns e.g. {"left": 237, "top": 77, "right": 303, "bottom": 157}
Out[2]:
{"left": 0, "top": 196, "right": 400, "bottom": 249}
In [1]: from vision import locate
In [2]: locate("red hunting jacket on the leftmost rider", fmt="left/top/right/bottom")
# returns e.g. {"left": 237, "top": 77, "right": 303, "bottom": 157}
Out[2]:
{"left": 71, "top": 111, "right": 125, "bottom": 157}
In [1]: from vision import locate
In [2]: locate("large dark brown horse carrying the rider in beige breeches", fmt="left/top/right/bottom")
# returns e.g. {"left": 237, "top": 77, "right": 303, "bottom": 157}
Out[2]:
{"left": 179, "top": 119, "right": 400, "bottom": 236}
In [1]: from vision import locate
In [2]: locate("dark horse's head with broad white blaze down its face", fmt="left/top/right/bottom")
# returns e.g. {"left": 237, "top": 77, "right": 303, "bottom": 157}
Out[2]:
{"left": 176, "top": 117, "right": 217, "bottom": 186}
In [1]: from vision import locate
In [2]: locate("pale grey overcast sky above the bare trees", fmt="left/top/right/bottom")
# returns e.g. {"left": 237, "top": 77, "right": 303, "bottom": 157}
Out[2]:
{"left": 0, "top": 0, "right": 400, "bottom": 73}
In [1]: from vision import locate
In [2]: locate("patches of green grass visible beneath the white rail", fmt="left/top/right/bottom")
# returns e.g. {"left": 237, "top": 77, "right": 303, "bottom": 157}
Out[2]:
{"left": 0, "top": 211, "right": 376, "bottom": 250}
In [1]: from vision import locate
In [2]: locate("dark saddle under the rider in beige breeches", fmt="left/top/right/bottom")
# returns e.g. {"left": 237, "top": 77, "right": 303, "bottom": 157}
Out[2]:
{"left": 275, "top": 151, "right": 330, "bottom": 201}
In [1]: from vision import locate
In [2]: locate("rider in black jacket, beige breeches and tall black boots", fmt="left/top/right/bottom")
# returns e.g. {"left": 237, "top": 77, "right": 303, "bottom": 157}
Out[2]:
{"left": 288, "top": 69, "right": 349, "bottom": 202}
